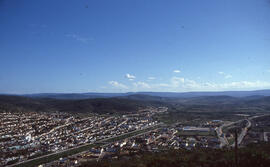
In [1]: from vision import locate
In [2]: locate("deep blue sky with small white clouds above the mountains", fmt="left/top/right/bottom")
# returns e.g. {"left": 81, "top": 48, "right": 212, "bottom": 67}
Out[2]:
{"left": 0, "top": 0, "right": 270, "bottom": 94}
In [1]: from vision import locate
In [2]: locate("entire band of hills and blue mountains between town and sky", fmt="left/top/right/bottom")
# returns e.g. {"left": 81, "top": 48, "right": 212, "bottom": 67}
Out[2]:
{"left": 0, "top": 90, "right": 270, "bottom": 113}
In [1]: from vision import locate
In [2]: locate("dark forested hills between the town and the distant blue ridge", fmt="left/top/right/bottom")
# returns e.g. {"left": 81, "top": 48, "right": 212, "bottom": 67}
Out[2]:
{"left": 0, "top": 95, "right": 270, "bottom": 113}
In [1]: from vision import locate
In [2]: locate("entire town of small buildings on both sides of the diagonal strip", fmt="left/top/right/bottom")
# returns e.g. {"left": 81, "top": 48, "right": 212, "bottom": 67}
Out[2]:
{"left": 0, "top": 107, "right": 270, "bottom": 167}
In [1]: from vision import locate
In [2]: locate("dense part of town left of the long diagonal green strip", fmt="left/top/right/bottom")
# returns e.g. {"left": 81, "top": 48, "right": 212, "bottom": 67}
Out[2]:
{"left": 0, "top": 108, "right": 167, "bottom": 165}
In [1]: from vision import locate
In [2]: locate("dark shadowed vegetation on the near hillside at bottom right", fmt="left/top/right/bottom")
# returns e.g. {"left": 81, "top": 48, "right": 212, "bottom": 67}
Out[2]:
{"left": 82, "top": 143, "right": 270, "bottom": 167}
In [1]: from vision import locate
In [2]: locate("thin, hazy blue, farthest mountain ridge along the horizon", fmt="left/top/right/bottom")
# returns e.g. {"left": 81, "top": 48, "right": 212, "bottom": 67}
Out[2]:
{"left": 22, "top": 90, "right": 270, "bottom": 99}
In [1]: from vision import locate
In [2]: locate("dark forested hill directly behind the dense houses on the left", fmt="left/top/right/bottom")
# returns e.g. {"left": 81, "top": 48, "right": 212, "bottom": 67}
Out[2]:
{"left": 0, "top": 95, "right": 160, "bottom": 113}
